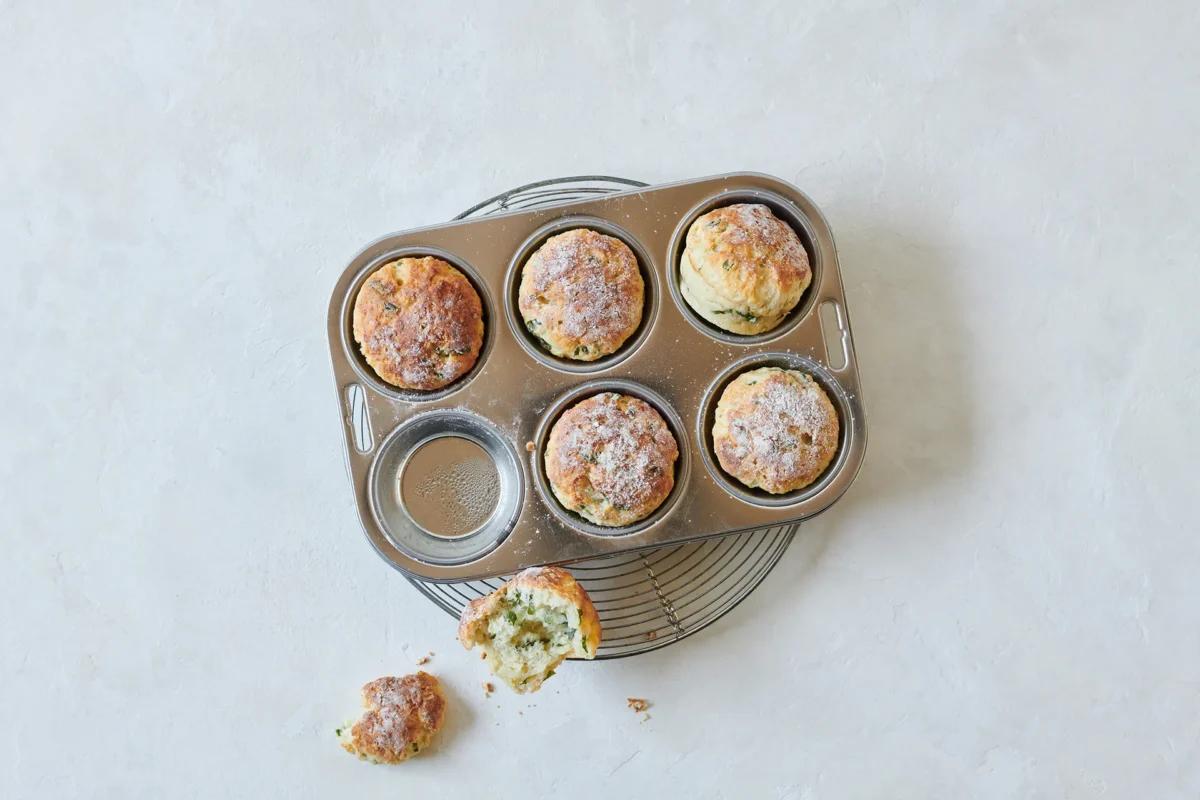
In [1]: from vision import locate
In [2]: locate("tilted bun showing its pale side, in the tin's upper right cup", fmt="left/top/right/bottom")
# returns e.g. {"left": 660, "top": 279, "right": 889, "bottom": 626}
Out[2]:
{"left": 679, "top": 203, "right": 812, "bottom": 335}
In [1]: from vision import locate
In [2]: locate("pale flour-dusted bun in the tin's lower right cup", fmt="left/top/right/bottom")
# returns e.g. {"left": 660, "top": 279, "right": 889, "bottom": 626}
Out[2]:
{"left": 713, "top": 367, "right": 839, "bottom": 494}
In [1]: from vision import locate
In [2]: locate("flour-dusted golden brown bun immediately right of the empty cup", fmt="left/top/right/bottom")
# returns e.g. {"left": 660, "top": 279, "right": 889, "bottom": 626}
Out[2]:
{"left": 546, "top": 392, "right": 679, "bottom": 527}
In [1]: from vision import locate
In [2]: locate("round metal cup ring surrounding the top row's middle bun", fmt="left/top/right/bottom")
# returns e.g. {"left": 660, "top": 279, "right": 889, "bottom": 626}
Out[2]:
{"left": 503, "top": 213, "right": 662, "bottom": 375}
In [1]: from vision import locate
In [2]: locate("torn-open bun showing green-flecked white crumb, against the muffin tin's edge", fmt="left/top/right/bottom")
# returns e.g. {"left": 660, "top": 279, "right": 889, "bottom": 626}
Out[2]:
{"left": 458, "top": 566, "right": 600, "bottom": 694}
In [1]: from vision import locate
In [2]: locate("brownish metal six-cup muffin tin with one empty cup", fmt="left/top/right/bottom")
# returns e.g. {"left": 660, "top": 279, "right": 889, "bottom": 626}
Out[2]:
{"left": 329, "top": 173, "right": 866, "bottom": 581}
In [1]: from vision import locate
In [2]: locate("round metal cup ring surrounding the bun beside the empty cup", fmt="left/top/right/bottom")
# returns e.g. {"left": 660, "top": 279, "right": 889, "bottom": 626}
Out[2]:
{"left": 529, "top": 378, "right": 691, "bottom": 539}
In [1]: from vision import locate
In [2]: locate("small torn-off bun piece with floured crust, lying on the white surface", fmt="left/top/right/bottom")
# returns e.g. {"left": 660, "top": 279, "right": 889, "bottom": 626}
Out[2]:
{"left": 337, "top": 672, "right": 446, "bottom": 764}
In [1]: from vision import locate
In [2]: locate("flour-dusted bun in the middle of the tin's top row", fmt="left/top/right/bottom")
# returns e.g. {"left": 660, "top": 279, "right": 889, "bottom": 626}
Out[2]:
{"left": 517, "top": 228, "right": 646, "bottom": 361}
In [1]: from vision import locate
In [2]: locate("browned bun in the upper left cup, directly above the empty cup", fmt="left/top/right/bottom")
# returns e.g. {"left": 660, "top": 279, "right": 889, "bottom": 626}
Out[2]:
{"left": 354, "top": 257, "right": 484, "bottom": 391}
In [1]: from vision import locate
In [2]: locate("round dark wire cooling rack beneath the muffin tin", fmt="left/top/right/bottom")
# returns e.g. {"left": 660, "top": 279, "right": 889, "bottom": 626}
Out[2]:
{"left": 408, "top": 175, "right": 799, "bottom": 658}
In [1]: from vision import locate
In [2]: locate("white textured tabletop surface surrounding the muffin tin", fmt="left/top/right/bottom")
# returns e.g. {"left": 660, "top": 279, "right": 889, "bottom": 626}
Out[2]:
{"left": 0, "top": 0, "right": 1200, "bottom": 800}
